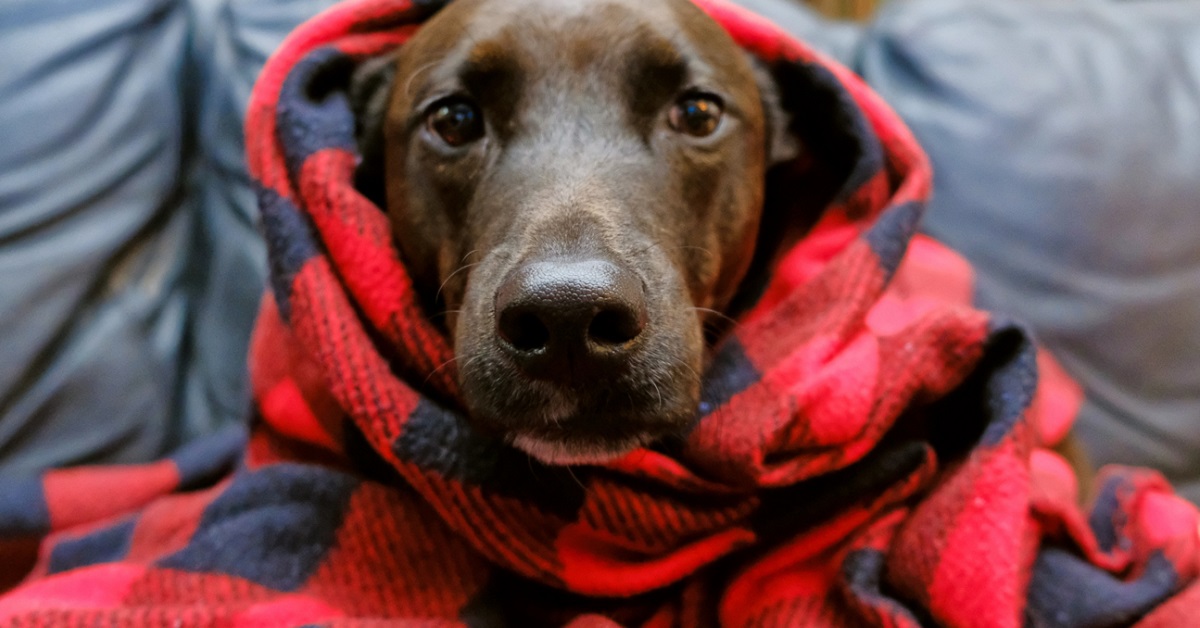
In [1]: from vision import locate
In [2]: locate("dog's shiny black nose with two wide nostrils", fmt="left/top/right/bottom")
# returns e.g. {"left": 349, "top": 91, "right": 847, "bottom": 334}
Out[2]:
{"left": 496, "top": 259, "right": 646, "bottom": 379}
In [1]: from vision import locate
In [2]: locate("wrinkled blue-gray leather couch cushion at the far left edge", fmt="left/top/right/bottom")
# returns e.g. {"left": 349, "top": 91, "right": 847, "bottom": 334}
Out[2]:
{"left": 0, "top": 0, "right": 191, "bottom": 474}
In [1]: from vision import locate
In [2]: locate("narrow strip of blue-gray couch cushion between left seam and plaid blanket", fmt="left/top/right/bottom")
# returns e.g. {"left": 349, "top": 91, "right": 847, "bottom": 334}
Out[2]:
{"left": 181, "top": 0, "right": 335, "bottom": 451}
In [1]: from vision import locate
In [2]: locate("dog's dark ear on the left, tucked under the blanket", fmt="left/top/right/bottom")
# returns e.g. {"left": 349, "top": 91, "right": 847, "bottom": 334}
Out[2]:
{"left": 348, "top": 54, "right": 396, "bottom": 208}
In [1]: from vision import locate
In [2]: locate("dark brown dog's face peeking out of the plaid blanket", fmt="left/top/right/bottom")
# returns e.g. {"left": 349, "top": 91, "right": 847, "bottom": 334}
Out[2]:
{"left": 364, "top": 0, "right": 788, "bottom": 463}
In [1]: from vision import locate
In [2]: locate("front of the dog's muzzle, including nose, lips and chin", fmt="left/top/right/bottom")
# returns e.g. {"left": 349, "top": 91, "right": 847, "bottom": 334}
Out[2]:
{"left": 456, "top": 252, "right": 703, "bottom": 465}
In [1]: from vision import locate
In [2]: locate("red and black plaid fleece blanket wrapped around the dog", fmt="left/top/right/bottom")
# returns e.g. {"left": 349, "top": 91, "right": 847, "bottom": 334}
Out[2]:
{"left": 0, "top": 0, "right": 1200, "bottom": 627}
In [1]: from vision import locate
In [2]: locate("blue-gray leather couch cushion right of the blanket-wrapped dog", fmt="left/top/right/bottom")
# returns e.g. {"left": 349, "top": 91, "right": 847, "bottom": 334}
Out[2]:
{"left": 858, "top": 0, "right": 1200, "bottom": 500}
